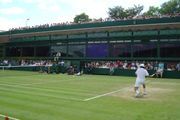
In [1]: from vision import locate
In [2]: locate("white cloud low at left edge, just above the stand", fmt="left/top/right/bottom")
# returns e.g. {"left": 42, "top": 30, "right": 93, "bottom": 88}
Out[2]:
{"left": 0, "top": 17, "right": 23, "bottom": 30}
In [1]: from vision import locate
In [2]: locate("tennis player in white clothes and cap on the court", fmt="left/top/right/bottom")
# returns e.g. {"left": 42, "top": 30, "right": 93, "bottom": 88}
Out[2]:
{"left": 134, "top": 64, "right": 152, "bottom": 97}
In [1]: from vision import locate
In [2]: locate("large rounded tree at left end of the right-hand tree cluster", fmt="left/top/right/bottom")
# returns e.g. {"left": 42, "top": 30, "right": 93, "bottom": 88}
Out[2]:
{"left": 108, "top": 6, "right": 127, "bottom": 19}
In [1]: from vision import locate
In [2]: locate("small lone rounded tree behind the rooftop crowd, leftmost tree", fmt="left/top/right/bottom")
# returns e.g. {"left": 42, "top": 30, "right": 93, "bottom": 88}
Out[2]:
{"left": 74, "top": 13, "right": 91, "bottom": 23}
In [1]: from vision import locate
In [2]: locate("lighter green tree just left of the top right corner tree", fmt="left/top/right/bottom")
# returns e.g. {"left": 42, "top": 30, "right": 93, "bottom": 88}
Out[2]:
{"left": 144, "top": 6, "right": 160, "bottom": 16}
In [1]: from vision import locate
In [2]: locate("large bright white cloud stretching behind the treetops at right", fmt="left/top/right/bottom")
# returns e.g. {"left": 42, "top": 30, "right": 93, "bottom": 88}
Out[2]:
{"left": 60, "top": 0, "right": 168, "bottom": 18}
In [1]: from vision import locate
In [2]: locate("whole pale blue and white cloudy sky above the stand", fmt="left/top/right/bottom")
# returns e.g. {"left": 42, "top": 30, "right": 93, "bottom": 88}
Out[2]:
{"left": 0, "top": 0, "right": 169, "bottom": 31}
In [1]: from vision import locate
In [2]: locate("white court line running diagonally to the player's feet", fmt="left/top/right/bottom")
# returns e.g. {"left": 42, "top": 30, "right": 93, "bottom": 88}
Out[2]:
{"left": 83, "top": 80, "right": 150, "bottom": 101}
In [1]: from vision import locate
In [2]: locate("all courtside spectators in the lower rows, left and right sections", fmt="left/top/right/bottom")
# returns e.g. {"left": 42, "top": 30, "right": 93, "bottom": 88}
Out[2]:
{"left": 0, "top": 60, "right": 180, "bottom": 71}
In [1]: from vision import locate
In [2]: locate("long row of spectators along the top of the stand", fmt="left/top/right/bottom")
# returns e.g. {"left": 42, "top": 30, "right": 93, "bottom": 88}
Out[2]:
{"left": 9, "top": 13, "right": 180, "bottom": 31}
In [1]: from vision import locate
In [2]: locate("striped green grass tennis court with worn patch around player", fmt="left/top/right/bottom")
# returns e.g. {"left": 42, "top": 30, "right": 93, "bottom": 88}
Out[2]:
{"left": 0, "top": 70, "right": 180, "bottom": 120}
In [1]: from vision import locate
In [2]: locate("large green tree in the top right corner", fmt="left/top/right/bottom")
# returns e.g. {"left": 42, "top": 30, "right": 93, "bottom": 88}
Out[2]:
{"left": 159, "top": 0, "right": 180, "bottom": 15}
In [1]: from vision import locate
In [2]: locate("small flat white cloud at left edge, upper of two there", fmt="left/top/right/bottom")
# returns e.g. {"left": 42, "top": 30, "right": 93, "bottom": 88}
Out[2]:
{"left": 0, "top": 7, "right": 24, "bottom": 14}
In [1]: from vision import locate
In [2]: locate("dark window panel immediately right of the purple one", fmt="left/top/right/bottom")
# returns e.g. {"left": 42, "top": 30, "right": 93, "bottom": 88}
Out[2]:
{"left": 109, "top": 44, "right": 131, "bottom": 57}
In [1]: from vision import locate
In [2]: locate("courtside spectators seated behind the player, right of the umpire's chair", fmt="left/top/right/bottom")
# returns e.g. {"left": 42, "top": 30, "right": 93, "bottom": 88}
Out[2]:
{"left": 85, "top": 60, "right": 180, "bottom": 71}
